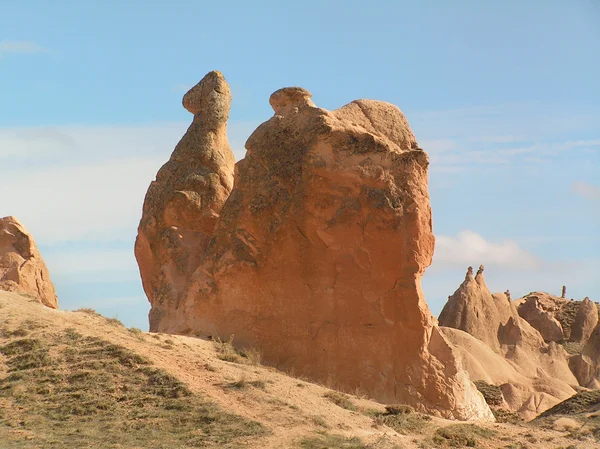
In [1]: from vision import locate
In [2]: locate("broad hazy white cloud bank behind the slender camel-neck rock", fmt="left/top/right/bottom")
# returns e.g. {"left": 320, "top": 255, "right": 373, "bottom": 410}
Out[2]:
{"left": 0, "top": 121, "right": 256, "bottom": 244}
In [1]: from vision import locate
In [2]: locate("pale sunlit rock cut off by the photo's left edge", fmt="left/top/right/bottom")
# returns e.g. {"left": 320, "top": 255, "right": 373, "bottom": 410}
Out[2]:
{"left": 0, "top": 217, "right": 58, "bottom": 309}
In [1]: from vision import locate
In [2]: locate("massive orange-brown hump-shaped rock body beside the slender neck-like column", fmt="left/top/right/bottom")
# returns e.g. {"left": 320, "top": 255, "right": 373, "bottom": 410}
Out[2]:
{"left": 178, "top": 88, "right": 493, "bottom": 420}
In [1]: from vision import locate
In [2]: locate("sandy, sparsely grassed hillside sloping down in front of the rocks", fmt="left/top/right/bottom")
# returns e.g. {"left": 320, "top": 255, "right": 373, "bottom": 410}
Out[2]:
{"left": 0, "top": 292, "right": 598, "bottom": 449}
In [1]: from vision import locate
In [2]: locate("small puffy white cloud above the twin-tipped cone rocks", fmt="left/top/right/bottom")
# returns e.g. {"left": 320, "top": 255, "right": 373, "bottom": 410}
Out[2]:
{"left": 433, "top": 230, "right": 540, "bottom": 269}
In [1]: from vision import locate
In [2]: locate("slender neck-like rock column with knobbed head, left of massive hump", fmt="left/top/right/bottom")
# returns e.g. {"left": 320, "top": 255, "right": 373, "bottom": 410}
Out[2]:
{"left": 135, "top": 72, "right": 235, "bottom": 331}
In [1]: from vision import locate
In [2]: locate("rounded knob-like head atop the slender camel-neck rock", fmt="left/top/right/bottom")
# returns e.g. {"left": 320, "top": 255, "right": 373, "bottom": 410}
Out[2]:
{"left": 182, "top": 70, "right": 231, "bottom": 115}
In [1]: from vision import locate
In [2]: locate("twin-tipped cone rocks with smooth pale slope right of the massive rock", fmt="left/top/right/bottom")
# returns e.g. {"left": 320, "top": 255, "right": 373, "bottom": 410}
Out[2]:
{"left": 439, "top": 267, "right": 589, "bottom": 420}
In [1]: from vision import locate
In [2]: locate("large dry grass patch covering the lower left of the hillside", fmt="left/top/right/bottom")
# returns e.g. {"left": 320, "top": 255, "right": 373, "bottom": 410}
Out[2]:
{"left": 0, "top": 322, "right": 265, "bottom": 449}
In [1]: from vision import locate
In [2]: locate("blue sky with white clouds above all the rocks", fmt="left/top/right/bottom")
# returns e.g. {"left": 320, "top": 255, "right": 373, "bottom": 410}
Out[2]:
{"left": 0, "top": 0, "right": 600, "bottom": 329}
